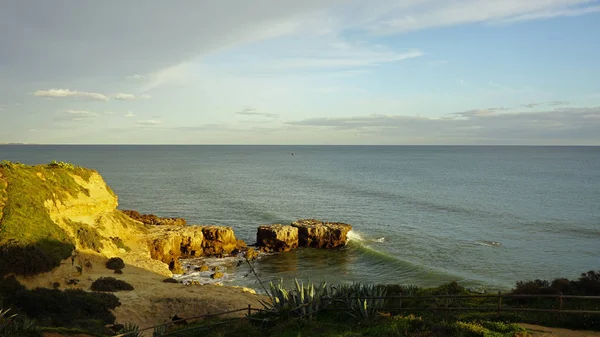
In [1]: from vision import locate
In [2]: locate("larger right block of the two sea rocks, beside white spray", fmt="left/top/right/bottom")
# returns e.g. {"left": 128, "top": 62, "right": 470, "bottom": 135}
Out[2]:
{"left": 292, "top": 219, "right": 352, "bottom": 248}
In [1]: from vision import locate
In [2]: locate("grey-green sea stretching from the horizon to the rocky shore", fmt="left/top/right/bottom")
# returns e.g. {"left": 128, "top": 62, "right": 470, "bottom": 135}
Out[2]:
{"left": 0, "top": 145, "right": 600, "bottom": 289}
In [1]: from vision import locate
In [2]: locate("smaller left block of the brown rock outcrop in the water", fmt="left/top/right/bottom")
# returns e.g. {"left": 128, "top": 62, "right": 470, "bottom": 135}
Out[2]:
{"left": 256, "top": 224, "right": 298, "bottom": 252}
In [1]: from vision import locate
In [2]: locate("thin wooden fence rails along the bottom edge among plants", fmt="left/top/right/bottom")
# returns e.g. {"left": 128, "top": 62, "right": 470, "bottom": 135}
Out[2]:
{"left": 114, "top": 292, "right": 600, "bottom": 337}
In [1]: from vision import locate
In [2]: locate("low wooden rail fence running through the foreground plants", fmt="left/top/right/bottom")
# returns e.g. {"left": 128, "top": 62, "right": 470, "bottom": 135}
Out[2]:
{"left": 115, "top": 292, "right": 600, "bottom": 337}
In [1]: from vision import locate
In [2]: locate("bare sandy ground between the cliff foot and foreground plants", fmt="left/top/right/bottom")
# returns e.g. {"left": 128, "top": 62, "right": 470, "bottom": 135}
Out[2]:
{"left": 18, "top": 254, "right": 265, "bottom": 335}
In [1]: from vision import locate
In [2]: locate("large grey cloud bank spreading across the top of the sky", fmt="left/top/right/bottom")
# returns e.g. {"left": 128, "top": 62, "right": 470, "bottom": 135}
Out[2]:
{"left": 0, "top": 0, "right": 600, "bottom": 80}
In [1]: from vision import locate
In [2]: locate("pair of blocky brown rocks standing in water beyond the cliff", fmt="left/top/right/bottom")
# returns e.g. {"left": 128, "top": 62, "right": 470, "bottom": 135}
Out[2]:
{"left": 256, "top": 219, "right": 352, "bottom": 252}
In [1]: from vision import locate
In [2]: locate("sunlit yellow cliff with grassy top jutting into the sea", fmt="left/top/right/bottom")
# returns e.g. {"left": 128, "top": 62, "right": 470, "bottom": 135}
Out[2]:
{"left": 0, "top": 162, "right": 245, "bottom": 276}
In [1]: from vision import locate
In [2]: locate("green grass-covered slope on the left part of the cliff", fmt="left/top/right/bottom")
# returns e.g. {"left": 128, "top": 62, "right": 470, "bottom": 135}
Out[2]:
{"left": 0, "top": 161, "right": 95, "bottom": 275}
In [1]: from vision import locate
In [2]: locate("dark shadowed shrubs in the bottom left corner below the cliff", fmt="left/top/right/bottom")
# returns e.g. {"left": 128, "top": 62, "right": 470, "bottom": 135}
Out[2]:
{"left": 0, "top": 276, "right": 121, "bottom": 336}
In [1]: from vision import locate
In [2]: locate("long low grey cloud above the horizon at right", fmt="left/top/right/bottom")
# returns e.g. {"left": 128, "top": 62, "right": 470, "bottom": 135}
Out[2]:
{"left": 287, "top": 107, "right": 600, "bottom": 144}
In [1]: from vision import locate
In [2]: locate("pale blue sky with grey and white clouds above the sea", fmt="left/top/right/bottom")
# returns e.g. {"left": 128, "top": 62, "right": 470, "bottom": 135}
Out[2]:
{"left": 0, "top": 0, "right": 600, "bottom": 145}
